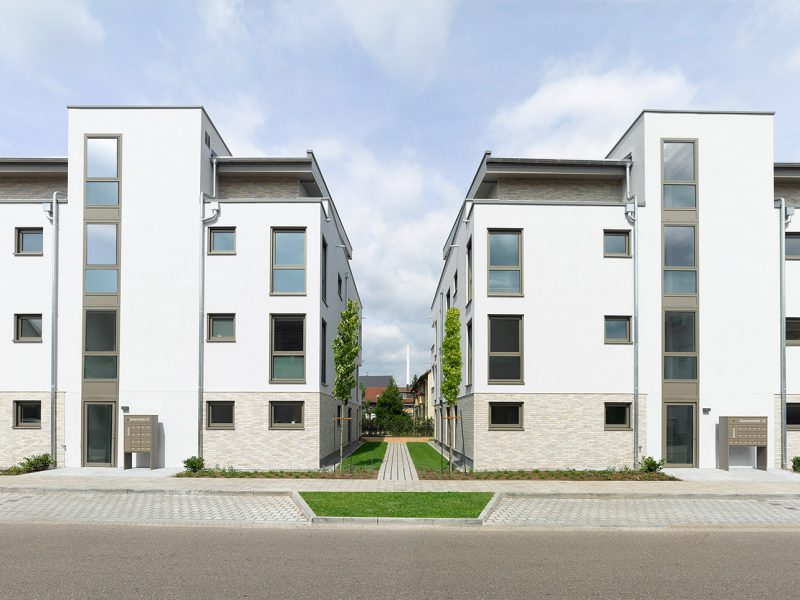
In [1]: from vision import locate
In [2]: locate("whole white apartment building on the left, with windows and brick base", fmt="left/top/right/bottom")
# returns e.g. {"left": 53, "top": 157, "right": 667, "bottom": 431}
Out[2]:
{"left": 0, "top": 106, "right": 360, "bottom": 469}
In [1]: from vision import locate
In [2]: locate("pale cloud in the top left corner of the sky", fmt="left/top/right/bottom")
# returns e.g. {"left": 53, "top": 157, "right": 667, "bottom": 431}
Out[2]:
{"left": 0, "top": 0, "right": 105, "bottom": 71}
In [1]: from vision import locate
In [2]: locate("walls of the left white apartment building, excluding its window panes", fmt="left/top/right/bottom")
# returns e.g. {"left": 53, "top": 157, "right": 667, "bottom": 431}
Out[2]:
{"left": 0, "top": 107, "right": 360, "bottom": 468}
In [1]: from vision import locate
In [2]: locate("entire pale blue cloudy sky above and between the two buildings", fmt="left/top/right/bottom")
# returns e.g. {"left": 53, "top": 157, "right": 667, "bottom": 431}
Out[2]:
{"left": 0, "top": 0, "right": 800, "bottom": 382}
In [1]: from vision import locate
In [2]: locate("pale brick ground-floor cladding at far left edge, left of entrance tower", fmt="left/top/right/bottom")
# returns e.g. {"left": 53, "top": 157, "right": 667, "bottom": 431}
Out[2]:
{"left": 0, "top": 392, "right": 64, "bottom": 468}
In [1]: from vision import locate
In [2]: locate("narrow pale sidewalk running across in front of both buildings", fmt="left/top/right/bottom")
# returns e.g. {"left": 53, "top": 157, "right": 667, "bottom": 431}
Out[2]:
{"left": 0, "top": 469, "right": 800, "bottom": 498}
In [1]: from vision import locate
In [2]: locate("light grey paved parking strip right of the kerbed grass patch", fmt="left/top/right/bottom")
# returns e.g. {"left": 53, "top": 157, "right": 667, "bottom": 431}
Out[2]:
{"left": 487, "top": 496, "right": 800, "bottom": 527}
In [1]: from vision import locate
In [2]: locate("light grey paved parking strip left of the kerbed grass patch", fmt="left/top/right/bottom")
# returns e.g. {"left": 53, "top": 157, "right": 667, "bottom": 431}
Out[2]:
{"left": 0, "top": 492, "right": 307, "bottom": 527}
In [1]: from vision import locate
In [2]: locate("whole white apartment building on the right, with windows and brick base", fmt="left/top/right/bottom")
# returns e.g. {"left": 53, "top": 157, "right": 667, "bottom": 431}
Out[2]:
{"left": 432, "top": 110, "right": 800, "bottom": 469}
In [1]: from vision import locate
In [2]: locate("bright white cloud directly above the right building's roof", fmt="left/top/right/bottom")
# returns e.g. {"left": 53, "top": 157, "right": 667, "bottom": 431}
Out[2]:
{"left": 487, "top": 67, "right": 697, "bottom": 158}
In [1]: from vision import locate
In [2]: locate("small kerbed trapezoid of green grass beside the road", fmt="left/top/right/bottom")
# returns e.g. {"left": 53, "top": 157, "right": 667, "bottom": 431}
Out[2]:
{"left": 300, "top": 492, "right": 492, "bottom": 519}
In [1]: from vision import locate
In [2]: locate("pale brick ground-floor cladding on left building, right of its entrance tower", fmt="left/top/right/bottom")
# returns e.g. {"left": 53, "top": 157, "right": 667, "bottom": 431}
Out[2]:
{"left": 203, "top": 392, "right": 320, "bottom": 470}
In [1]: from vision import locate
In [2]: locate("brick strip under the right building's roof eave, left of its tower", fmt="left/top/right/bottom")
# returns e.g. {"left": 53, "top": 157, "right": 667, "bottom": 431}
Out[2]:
{"left": 497, "top": 179, "right": 623, "bottom": 203}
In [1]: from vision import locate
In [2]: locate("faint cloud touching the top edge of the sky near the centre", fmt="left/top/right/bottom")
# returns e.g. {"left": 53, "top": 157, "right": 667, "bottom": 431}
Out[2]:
{"left": 336, "top": 0, "right": 456, "bottom": 87}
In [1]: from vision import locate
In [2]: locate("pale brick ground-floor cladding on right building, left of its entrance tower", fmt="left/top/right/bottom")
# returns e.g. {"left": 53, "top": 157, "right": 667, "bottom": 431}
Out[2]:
{"left": 470, "top": 394, "right": 647, "bottom": 470}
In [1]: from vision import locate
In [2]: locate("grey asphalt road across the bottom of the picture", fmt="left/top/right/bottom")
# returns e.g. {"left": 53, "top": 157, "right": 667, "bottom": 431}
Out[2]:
{"left": 0, "top": 525, "right": 800, "bottom": 600}
